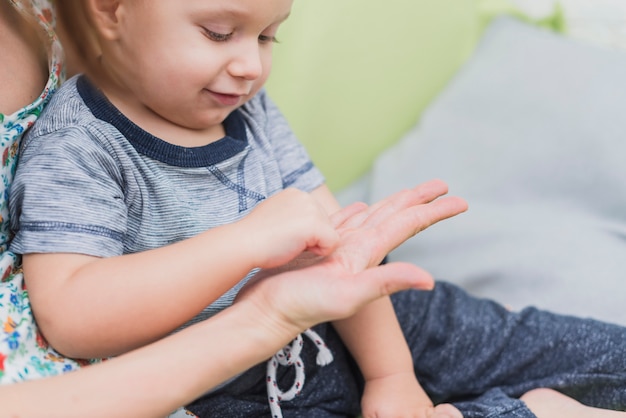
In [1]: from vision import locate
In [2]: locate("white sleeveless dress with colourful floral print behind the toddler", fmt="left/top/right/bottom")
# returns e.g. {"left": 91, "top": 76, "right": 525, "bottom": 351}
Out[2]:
{"left": 0, "top": 0, "right": 89, "bottom": 384}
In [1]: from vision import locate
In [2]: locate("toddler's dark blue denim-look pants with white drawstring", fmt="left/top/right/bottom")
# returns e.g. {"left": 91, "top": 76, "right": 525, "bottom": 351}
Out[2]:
{"left": 188, "top": 282, "right": 626, "bottom": 418}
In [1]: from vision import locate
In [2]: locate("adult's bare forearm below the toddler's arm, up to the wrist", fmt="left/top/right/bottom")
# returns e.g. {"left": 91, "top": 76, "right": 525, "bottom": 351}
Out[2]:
{"left": 0, "top": 303, "right": 301, "bottom": 418}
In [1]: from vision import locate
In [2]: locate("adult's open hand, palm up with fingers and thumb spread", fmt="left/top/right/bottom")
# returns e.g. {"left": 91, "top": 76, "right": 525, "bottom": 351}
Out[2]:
{"left": 237, "top": 180, "right": 467, "bottom": 333}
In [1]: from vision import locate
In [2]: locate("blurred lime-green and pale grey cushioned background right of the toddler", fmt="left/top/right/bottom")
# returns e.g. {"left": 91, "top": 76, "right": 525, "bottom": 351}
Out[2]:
{"left": 268, "top": 0, "right": 626, "bottom": 324}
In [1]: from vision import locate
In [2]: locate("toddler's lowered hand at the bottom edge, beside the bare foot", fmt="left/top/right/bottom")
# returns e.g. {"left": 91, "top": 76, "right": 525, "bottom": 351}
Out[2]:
{"left": 361, "top": 372, "right": 463, "bottom": 418}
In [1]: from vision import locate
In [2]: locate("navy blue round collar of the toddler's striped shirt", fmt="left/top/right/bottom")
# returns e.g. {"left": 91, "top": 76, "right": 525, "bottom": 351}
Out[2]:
{"left": 76, "top": 75, "right": 248, "bottom": 167}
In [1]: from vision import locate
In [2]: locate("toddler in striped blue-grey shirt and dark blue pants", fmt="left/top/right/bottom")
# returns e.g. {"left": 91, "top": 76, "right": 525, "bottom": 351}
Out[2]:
{"left": 11, "top": 0, "right": 626, "bottom": 417}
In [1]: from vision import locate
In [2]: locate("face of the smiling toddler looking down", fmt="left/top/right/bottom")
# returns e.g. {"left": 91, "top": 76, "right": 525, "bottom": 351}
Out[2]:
{"left": 102, "top": 0, "right": 292, "bottom": 130}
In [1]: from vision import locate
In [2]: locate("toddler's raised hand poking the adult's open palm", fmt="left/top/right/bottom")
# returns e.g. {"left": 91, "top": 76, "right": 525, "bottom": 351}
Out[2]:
{"left": 240, "top": 189, "right": 339, "bottom": 268}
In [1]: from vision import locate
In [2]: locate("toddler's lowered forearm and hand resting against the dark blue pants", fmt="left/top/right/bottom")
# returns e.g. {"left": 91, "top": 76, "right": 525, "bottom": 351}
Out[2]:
{"left": 313, "top": 186, "right": 442, "bottom": 417}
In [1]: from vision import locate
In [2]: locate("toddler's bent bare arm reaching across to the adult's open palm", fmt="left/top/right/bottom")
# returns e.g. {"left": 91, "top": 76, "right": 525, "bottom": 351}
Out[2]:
{"left": 23, "top": 189, "right": 338, "bottom": 358}
